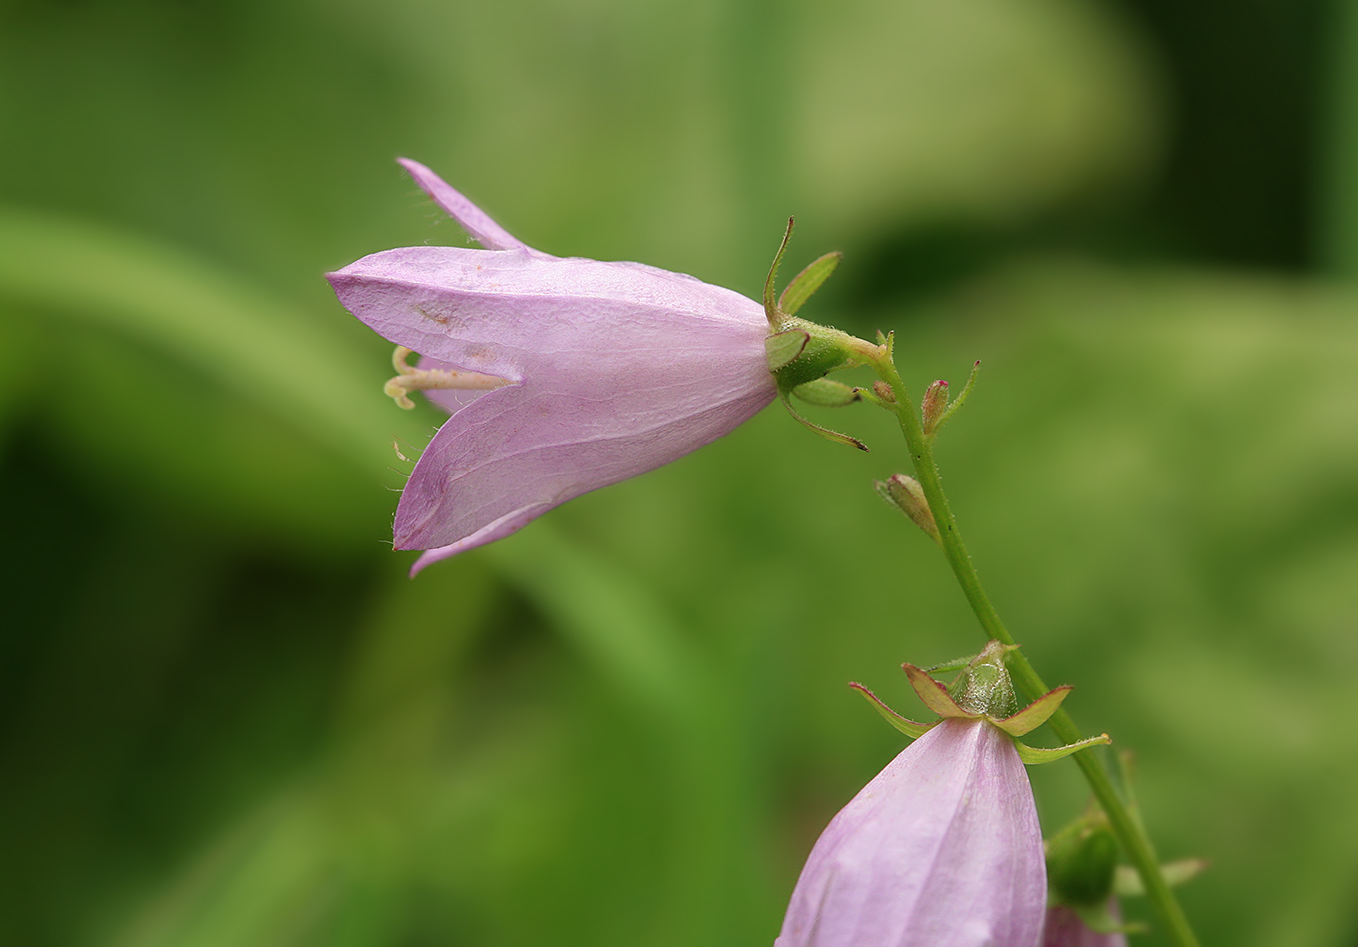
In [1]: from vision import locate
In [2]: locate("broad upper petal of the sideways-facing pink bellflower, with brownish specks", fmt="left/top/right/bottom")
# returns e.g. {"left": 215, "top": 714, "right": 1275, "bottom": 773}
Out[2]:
{"left": 329, "top": 247, "right": 773, "bottom": 385}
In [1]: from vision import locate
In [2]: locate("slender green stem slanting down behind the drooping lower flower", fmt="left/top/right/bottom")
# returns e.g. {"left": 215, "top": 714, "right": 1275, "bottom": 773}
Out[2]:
{"left": 870, "top": 348, "right": 1198, "bottom": 947}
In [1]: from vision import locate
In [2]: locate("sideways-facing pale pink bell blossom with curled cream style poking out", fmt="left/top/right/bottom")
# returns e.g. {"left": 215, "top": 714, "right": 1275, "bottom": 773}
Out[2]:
{"left": 329, "top": 159, "right": 778, "bottom": 572}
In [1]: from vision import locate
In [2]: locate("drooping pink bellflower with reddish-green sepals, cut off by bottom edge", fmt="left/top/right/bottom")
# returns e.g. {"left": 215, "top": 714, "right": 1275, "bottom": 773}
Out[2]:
{"left": 775, "top": 641, "right": 1108, "bottom": 947}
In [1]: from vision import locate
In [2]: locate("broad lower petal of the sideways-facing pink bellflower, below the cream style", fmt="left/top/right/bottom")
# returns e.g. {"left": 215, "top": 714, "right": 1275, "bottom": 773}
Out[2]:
{"left": 395, "top": 360, "right": 773, "bottom": 557}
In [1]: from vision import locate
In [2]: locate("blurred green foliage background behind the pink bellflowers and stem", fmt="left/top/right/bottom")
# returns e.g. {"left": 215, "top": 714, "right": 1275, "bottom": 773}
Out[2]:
{"left": 0, "top": 0, "right": 1358, "bottom": 947}
